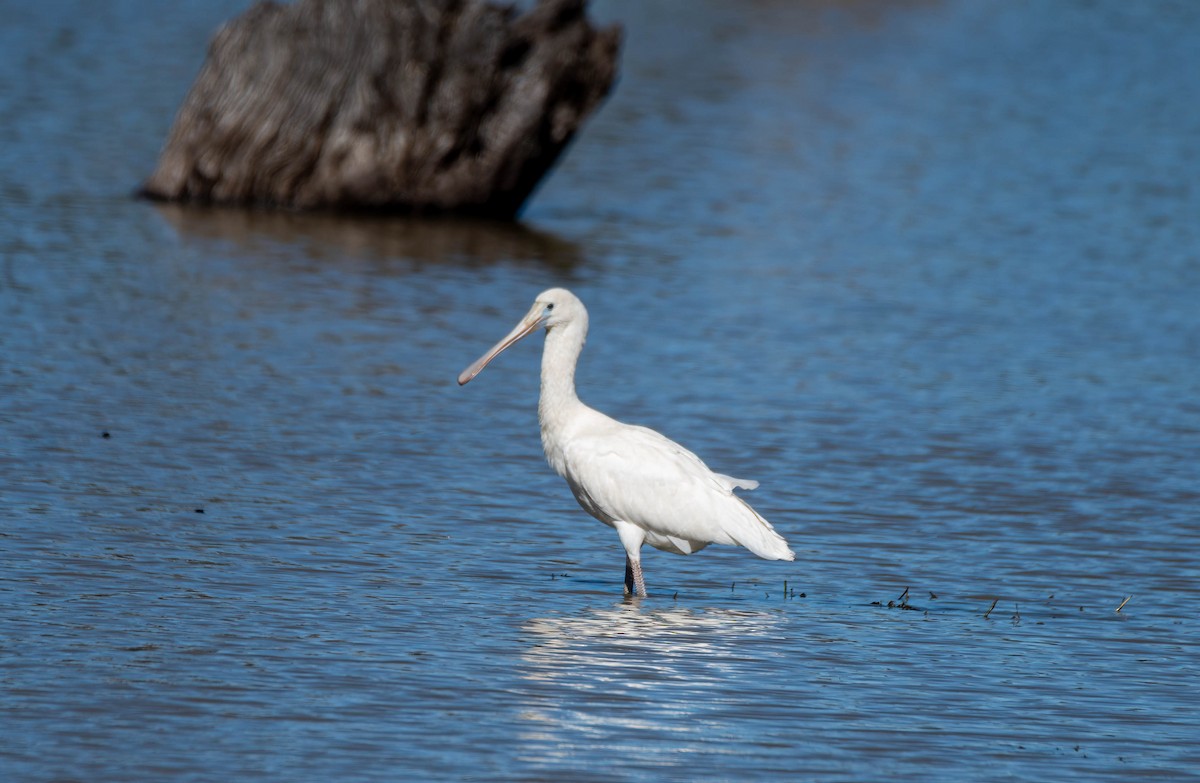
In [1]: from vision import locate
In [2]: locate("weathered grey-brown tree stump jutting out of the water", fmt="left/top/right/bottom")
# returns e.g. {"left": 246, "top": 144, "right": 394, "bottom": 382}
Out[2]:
{"left": 142, "top": 0, "right": 620, "bottom": 217}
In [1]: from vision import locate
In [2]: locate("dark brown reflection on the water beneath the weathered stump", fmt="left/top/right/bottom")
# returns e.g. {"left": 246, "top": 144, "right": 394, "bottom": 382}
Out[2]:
{"left": 155, "top": 204, "right": 583, "bottom": 271}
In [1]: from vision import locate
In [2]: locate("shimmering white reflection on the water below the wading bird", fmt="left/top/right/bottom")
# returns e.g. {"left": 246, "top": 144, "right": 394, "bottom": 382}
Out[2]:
{"left": 518, "top": 602, "right": 787, "bottom": 765}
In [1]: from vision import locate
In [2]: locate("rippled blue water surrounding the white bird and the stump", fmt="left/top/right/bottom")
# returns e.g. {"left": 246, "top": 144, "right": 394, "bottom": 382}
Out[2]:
{"left": 0, "top": 0, "right": 1200, "bottom": 781}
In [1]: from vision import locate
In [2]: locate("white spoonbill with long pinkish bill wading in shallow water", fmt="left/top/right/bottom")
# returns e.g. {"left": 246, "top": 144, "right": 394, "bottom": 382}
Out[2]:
{"left": 458, "top": 288, "right": 796, "bottom": 596}
